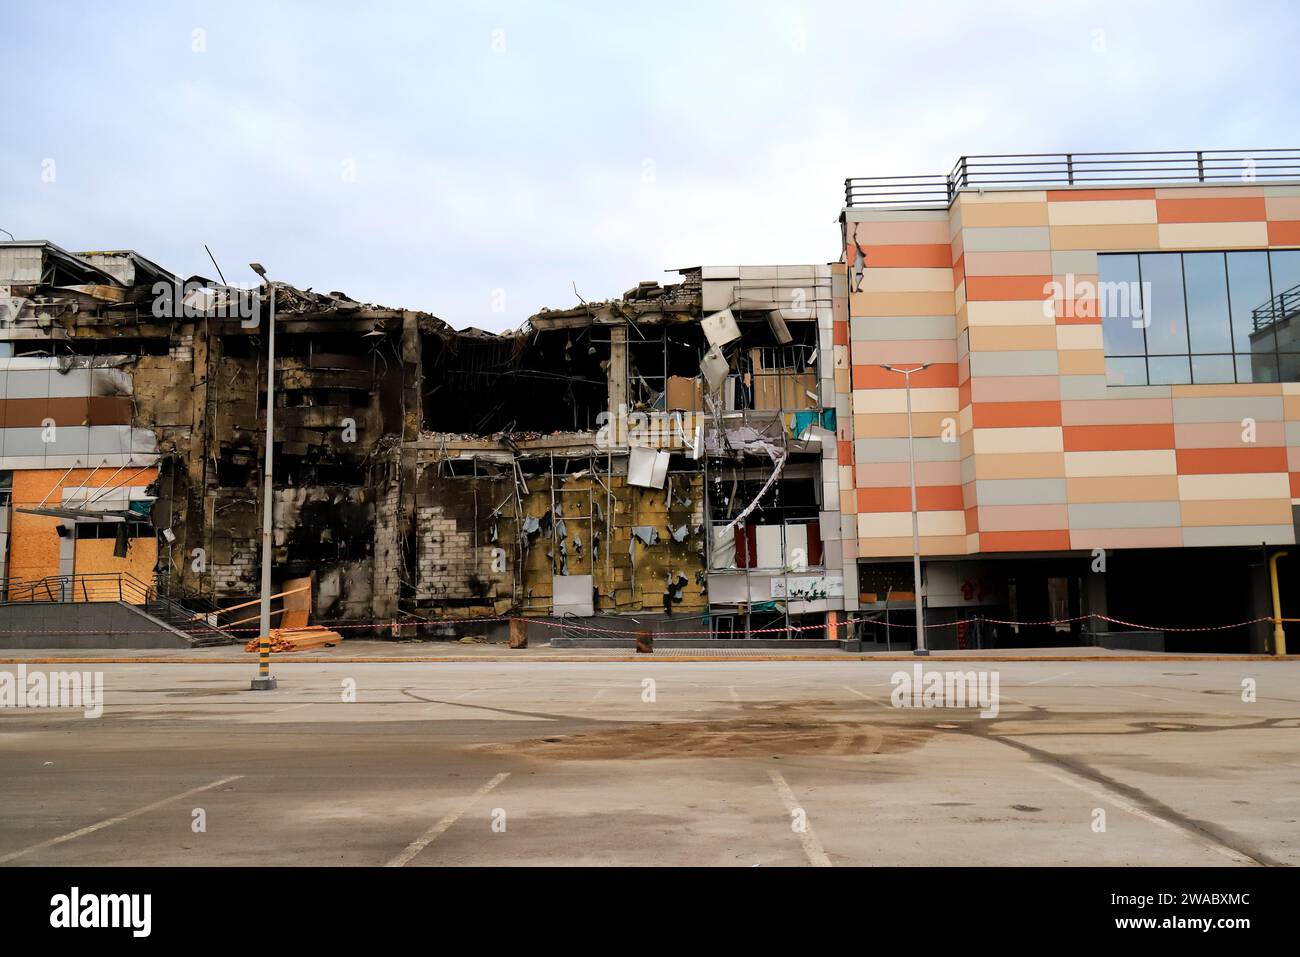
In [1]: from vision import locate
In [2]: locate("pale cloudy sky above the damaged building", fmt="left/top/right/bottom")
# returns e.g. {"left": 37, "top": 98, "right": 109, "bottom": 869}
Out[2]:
{"left": 0, "top": 0, "right": 1300, "bottom": 330}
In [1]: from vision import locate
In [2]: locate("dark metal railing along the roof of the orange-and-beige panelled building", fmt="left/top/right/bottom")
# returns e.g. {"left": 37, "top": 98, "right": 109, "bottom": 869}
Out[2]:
{"left": 844, "top": 150, "right": 1300, "bottom": 208}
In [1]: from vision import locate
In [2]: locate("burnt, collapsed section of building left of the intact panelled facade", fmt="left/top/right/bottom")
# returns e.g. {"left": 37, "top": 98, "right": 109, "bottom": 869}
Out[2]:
{"left": 0, "top": 242, "right": 855, "bottom": 637}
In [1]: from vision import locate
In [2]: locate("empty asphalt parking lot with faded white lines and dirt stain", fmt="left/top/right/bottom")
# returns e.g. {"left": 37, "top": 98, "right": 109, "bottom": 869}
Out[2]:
{"left": 0, "top": 658, "right": 1300, "bottom": 867}
